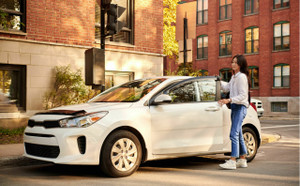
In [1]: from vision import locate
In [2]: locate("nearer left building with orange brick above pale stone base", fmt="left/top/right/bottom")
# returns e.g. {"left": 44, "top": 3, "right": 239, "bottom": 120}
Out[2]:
{"left": 0, "top": 0, "right": 163, "bottom": 115}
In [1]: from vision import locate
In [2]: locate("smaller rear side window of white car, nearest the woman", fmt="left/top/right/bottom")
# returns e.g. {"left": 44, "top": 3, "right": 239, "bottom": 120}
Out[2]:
{"left": 197, "top": 79, "right": 217, "bottom": 102}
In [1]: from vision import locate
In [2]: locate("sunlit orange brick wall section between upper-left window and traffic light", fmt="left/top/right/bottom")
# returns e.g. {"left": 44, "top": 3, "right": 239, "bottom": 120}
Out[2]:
{"left": 26, "top": 0, "right": 95, "bottom": 46}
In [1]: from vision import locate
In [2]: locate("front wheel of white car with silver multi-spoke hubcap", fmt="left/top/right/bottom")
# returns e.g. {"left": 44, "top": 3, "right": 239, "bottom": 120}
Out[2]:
{"left": 100, "top": 130, "right": 142, "bottom": 177}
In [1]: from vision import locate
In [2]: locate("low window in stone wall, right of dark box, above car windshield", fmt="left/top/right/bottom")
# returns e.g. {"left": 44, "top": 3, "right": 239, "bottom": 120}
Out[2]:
{"left": 105, "top": 71, "right": 134, "bottom": 89}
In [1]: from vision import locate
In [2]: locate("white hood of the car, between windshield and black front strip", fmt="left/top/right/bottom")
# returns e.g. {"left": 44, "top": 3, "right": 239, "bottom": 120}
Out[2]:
{"left": 51, "top": 102, "right": 133, "bottom": 113}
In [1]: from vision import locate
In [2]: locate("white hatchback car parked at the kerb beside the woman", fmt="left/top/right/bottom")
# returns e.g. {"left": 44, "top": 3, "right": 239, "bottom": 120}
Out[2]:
{"left": 24, "top": 77, "right": 261, "bottom": 177}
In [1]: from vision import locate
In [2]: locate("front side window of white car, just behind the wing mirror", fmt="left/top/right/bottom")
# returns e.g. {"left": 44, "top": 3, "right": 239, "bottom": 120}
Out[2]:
{"left": 168, "top": 81, "right": 199, "bottom": 103}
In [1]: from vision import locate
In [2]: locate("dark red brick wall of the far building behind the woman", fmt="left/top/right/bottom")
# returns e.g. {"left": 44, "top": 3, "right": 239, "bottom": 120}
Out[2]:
{"left": 166, "top": 0, "right": 299, "bottom": 97}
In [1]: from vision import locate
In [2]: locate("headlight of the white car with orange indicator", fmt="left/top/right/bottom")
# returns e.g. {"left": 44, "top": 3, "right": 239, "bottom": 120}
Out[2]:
{"left": 59, "top": 112, "right": 108, "bottom": 128}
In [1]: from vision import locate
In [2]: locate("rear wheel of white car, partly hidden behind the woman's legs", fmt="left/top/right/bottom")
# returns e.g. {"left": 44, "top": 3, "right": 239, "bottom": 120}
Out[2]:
{"left": 243, "top": 127, "right": 258, "bottom": 162}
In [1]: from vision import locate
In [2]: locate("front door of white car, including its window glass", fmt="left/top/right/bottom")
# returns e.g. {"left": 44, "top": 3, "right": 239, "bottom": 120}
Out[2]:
{"left": 150, "top": 78, "right": 223, "bottom": 155}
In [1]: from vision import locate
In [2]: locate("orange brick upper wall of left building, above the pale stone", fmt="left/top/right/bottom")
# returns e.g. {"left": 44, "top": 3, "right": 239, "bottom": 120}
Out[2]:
{"left": 0, "top": 0, "right": 163, "bottom": 54}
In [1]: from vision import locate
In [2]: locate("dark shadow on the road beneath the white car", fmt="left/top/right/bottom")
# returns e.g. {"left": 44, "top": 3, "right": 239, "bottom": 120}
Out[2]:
{"left": 0, "top": 157, "right": 223, "bottom": 179}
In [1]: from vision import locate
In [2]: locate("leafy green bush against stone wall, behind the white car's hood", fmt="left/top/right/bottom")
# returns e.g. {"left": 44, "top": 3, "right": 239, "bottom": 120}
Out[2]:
{"left": 43, "top": 65, "right": 100, "bottom": 109}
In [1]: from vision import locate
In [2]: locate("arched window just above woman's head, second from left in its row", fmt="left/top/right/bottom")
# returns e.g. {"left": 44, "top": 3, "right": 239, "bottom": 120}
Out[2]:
{"left": 219, "top": 31, "right": 232, "bottom": 56}
